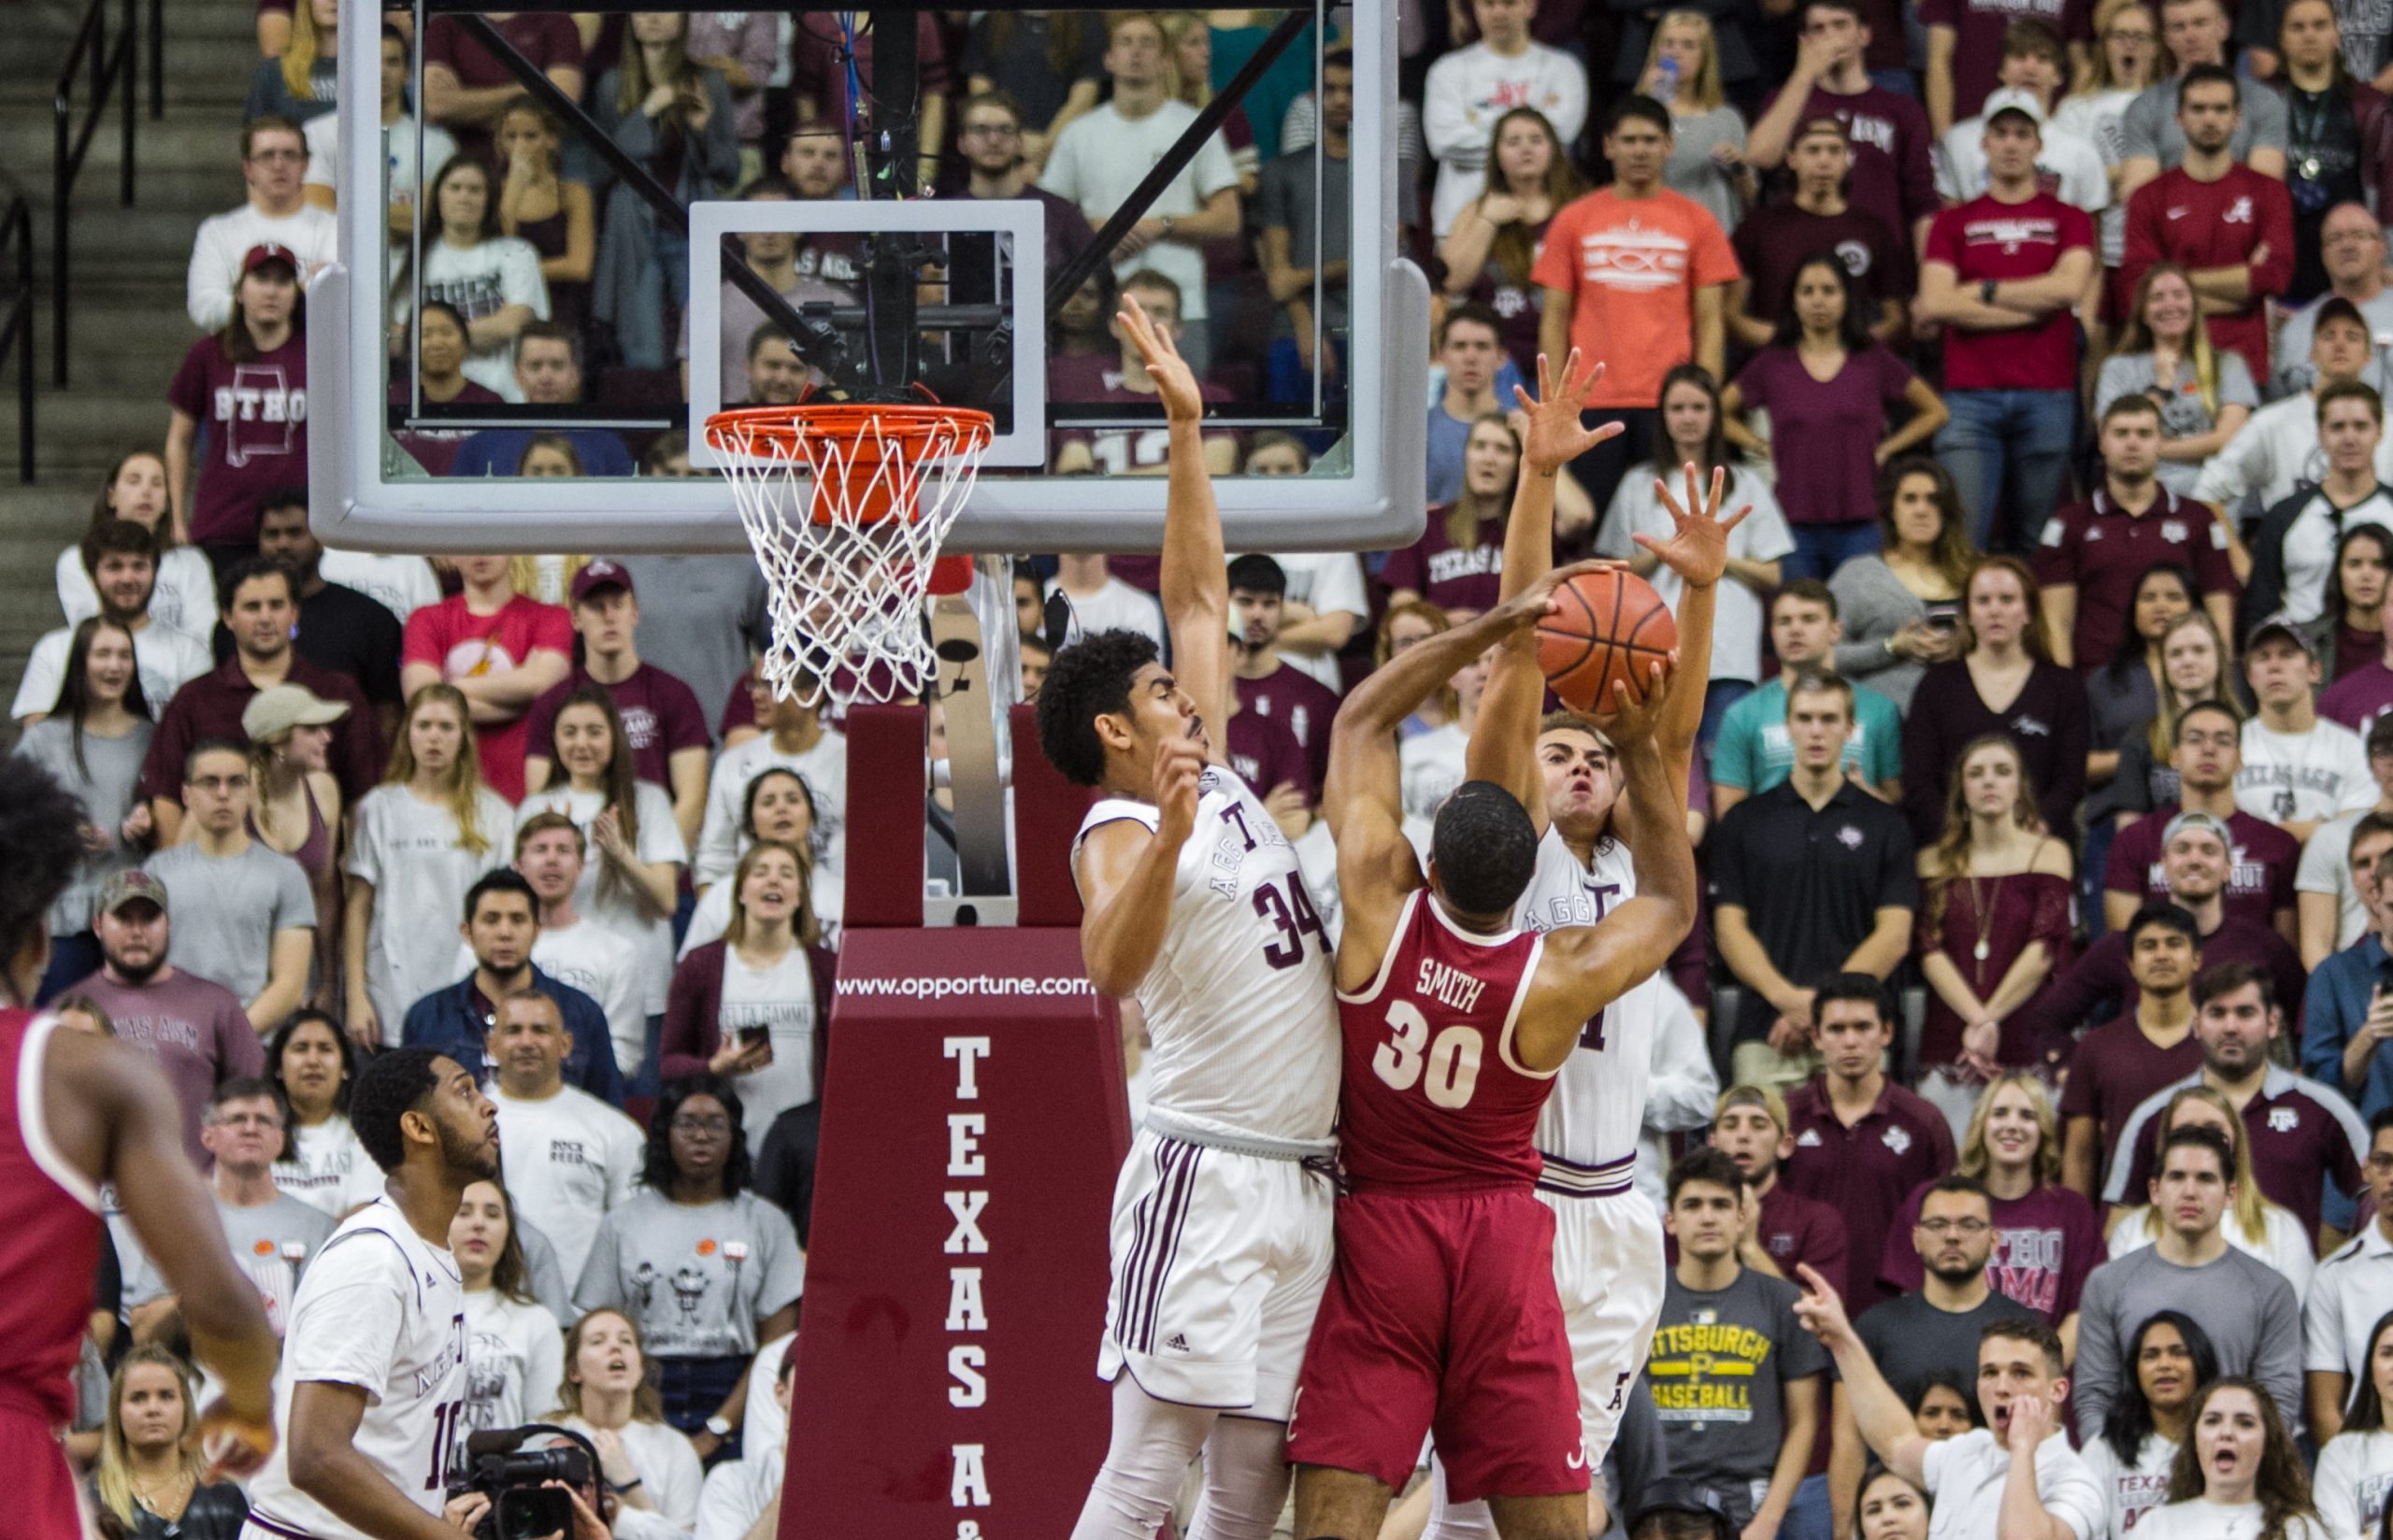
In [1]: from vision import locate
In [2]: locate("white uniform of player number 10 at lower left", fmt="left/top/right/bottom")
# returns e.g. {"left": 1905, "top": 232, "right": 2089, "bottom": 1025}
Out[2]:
{"left": 249, "top": 1198, "right": 466, "bottom": 1540}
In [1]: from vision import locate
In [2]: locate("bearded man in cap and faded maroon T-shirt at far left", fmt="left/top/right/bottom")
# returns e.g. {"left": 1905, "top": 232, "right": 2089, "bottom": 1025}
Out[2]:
{"left": 69, "top": 868, "right": 265, "bottom": 1169}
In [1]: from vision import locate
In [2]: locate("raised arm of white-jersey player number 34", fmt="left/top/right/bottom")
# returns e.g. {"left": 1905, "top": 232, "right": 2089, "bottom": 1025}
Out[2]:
{"left": 1118, "top": 294, "right": 1230, "bottom": 765}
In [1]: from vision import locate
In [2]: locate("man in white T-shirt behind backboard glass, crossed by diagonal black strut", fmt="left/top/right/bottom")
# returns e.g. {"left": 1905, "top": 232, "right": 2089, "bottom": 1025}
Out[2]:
{"left": 1039, "top": 11, "right": 1244, "bottom": 376}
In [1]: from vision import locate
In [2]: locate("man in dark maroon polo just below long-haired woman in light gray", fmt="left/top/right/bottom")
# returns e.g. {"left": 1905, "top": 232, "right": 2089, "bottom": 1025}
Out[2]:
{"left": 2037, "top": 394, "right": 2235, "bottom": 672}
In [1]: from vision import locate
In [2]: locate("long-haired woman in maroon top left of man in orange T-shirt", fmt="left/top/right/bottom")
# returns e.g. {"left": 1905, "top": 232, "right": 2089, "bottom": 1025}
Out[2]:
{"left": 1439, "top": 107, "right": 1586, "bottom": 380}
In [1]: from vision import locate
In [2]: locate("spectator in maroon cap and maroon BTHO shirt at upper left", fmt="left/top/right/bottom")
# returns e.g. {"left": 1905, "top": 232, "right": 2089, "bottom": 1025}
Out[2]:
{"left": 165, "top": 244, "right": 307, "bottom": 577}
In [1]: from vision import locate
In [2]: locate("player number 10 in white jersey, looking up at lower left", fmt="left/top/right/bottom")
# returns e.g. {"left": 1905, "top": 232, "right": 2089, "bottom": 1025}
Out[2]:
{"left": 242, "top": 1048, "right": 497, "bottom": 1540}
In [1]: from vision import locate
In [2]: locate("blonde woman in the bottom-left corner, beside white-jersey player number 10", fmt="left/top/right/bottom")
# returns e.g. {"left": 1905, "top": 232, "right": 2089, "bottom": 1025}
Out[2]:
{"left": 91, "top": 1347, "right": 249, "bottom": 1540}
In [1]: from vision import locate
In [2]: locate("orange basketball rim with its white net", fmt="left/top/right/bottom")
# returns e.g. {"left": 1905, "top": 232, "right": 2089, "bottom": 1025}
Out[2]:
{"left": 706, "top": 399, "right": 993, "bottom": 706}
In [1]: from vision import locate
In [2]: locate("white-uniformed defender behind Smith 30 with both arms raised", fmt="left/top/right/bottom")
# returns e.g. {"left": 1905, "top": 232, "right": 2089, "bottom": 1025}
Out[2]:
{"left": 1426, "top": 351, "right": 1744, "bottom": 1540}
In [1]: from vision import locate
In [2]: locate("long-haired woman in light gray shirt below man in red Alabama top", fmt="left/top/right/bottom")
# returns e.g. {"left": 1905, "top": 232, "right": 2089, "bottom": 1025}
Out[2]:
{"left": 2080, "top": 263, "right": 2259, "bottom": 492}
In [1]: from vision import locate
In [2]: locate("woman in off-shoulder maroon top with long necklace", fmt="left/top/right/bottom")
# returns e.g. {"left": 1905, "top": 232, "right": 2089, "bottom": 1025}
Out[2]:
{"left": 1905, "top": 734, "right": 2072, "bottom": 1128}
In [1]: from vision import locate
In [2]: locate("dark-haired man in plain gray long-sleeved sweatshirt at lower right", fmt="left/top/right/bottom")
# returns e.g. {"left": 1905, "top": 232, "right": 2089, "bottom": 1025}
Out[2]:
{"left": 2077, "top": 1126, "right": 2302, "bottom": 1428}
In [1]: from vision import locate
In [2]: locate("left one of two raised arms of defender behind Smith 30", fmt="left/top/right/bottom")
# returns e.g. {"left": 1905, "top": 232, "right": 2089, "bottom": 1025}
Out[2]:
{"left": 1465, "top": 349, "right": 1617, "bottom": 834}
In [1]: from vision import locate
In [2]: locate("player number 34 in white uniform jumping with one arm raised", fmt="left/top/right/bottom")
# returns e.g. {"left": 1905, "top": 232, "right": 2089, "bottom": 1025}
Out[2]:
{"left": 1039, "top": 296, "right": 1340, "bottom": 1540}
